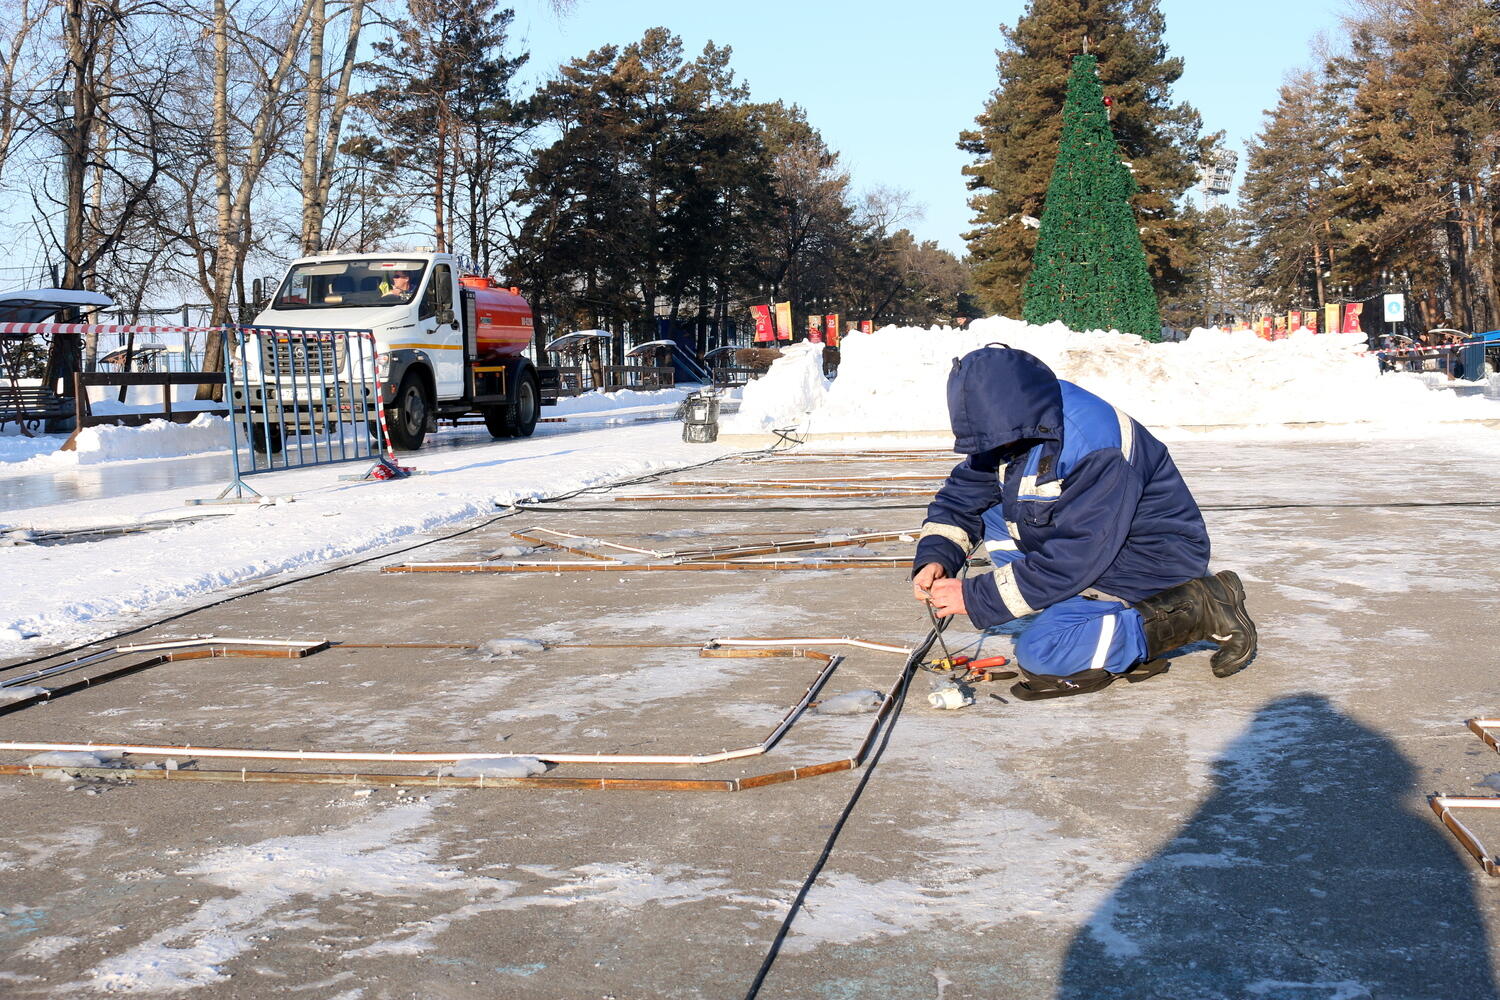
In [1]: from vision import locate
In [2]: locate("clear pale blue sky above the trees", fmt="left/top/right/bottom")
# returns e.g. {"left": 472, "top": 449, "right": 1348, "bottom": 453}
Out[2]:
{"left": 513, "top": 0, "right": 1346, "bottom": 253}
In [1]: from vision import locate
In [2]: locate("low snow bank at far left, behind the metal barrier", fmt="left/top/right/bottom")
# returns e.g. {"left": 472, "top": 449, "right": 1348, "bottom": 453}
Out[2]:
{"left": 0, "top": 414, "right": 230, "bottom": 474}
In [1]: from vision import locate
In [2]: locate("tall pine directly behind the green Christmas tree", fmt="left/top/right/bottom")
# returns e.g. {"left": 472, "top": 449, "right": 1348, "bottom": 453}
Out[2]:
{"left": 959, "top": 0, "right": 1215, "bottom": 315}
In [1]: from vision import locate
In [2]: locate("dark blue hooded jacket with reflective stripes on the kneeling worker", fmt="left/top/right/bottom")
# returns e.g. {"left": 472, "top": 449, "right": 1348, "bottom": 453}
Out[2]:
{"left": 915, "top": 346, "right": 1209, "bottom": 628}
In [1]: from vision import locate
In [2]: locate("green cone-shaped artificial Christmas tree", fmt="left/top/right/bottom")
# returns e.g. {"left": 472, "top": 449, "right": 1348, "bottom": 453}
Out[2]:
{"left": 1023, "top": 55, "right": 1161, "bottom": 340}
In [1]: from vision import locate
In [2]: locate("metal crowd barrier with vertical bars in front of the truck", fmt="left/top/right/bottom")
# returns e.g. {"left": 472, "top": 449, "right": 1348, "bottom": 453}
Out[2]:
{"left": 216, "top": 327, "right": 395, "bottom": 501}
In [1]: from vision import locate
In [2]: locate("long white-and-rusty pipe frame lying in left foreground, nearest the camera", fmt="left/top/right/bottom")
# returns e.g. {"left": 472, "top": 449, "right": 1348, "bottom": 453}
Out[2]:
{"left": 0, "top": 637, "right": 911, "bottom": 790}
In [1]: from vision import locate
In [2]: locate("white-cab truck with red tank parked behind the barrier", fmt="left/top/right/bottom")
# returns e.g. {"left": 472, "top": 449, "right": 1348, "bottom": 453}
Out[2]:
{"left": 255, "top": 250, "right": 557, "bottom": 450}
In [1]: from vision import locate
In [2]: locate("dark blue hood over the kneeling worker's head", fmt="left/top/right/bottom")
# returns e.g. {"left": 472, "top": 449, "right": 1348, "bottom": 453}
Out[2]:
{"left": 948, "top": 345, "right": 1062, "bottom": 454}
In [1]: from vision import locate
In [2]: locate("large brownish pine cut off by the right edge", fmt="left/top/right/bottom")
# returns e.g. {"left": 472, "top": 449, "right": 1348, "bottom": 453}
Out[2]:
{"left": 1335, "top": 0, "right": 1500, "bottom": 330}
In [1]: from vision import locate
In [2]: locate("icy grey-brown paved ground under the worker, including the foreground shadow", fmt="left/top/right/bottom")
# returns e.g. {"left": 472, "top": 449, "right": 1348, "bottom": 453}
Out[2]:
{"left": 0, "top": 429, "right": 1500, "bottom": 1000}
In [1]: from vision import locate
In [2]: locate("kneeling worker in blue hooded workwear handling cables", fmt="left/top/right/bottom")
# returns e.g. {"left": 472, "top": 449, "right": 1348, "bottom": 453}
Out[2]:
{"left": 912, "top": 345, "right": 1256, "bottom": 700}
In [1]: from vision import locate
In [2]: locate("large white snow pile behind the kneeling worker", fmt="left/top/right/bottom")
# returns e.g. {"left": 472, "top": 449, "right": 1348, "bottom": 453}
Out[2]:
{"left": 723, "top": 316, "right": 1500, "bottom": 435}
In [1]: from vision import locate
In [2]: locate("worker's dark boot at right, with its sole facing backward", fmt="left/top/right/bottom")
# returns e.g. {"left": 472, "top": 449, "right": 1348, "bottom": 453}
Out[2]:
{"left": 1134, "top": 570, "right": 1256, "bottom": 678}
